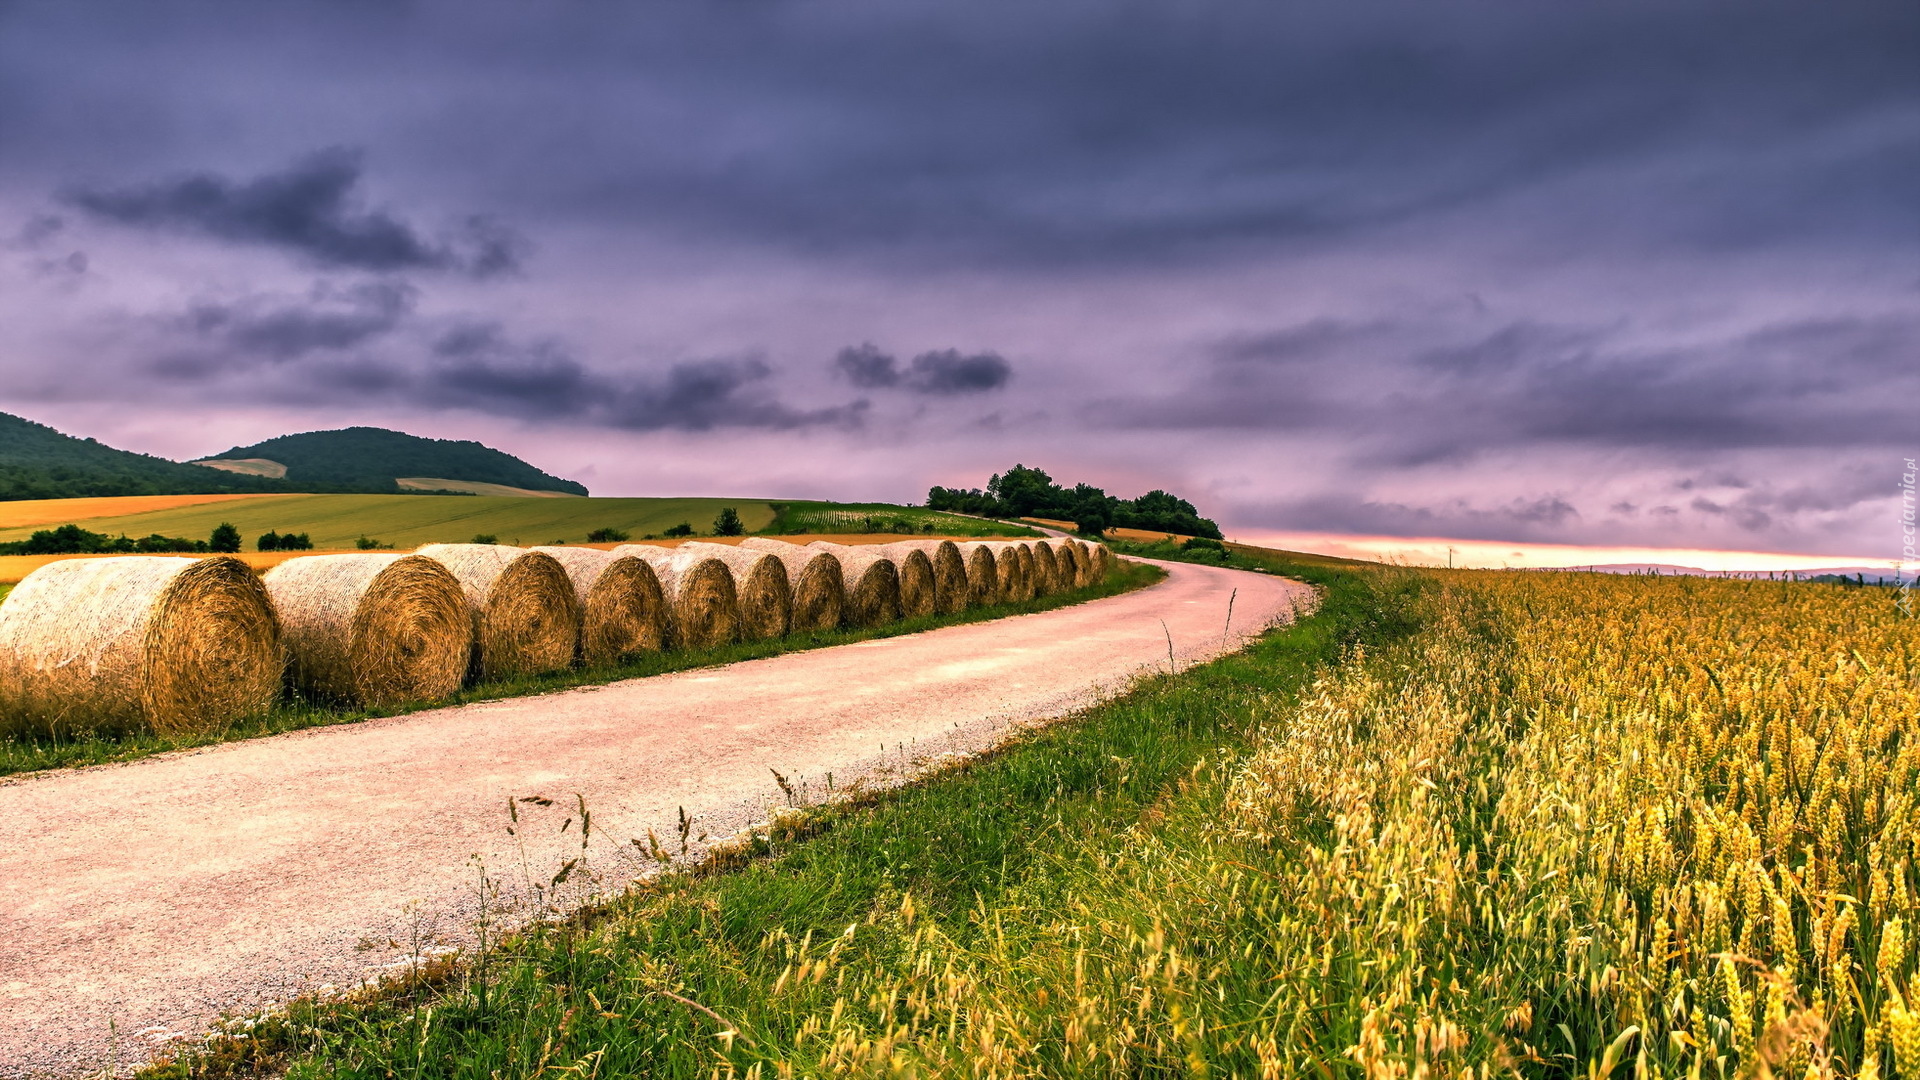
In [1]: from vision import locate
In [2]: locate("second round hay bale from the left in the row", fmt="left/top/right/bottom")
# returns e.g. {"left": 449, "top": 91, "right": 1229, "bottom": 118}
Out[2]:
{"left": 265, "top": 552, "right": 474, "bottom": 707}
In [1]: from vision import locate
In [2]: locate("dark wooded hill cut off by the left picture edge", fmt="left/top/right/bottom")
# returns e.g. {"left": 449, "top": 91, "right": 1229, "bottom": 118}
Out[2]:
{"left": 0, "top": 413, "right": 296, "bottom": 500}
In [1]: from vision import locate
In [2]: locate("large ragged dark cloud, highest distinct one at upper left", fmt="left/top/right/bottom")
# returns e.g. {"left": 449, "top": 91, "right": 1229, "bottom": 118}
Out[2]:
{"left": 63, "top": 148, "right": 522, "bottom": 277}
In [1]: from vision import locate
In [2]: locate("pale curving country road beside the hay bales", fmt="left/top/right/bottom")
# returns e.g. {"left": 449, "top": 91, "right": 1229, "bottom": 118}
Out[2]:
{"left": 0, "top": 563, "right": 1309, "bottom": 1076}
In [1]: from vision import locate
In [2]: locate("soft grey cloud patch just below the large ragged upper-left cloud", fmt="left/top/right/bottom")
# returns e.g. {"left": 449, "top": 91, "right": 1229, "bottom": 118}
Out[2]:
{"left": 184, "top": 281, "right": 417, "bottom": 361}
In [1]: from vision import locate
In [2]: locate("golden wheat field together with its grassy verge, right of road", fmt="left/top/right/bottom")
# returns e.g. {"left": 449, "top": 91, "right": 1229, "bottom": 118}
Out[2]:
{"left": 165, "top": 546, "right": 1920, "bottom": 1080}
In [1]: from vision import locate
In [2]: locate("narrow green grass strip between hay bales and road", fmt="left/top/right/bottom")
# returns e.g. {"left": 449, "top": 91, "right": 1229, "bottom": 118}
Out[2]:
{"left": 0, "top": 563, "right": 1165, "bottom": 776}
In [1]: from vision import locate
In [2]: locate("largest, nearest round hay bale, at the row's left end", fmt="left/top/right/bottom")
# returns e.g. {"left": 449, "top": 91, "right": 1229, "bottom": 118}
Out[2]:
{"left": 0, "top": 555, "right": 284, "bottom": 736}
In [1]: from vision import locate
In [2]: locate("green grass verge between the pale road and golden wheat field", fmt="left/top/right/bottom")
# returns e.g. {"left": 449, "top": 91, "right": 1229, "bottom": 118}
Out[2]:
{"left": 154, "top": 555, "right": 1411, "bottom": 1080}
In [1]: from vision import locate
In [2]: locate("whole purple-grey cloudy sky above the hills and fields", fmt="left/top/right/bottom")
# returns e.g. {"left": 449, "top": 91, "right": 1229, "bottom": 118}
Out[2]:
{"left": 0, "top": 0, "right": 1920, "bottom": 557}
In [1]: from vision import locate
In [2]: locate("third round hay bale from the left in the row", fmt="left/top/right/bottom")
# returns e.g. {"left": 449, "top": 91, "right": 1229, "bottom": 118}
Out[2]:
{"left": 417, "top": 544, "right": 580, "bottom": 678}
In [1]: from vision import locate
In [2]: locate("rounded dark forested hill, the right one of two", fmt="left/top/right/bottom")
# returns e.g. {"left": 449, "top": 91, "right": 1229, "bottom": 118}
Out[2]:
{"left": 198, "top": 427, "right": 588, "bottom": 496}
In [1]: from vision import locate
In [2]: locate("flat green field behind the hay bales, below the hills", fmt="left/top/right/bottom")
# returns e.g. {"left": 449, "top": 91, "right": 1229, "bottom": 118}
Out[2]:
{"left": 0, "top": 496, "right": 774, "bottom": 550}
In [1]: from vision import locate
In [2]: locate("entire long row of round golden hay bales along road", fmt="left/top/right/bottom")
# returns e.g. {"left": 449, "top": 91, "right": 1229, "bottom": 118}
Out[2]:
{"left": 0, "top": 538, "right": 1110, "bottom": 734}
